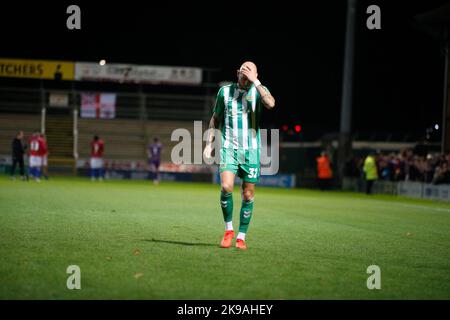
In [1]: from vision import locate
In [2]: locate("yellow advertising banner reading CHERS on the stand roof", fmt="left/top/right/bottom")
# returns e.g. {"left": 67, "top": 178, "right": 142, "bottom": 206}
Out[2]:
{"left": 0, "top": 58, "right": 75, "bottom": 80}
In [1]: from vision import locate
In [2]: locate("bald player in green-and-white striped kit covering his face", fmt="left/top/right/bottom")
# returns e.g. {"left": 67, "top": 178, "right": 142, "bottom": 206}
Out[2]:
{"left": 204, "top": 61, "right": 275, "bottom": 249}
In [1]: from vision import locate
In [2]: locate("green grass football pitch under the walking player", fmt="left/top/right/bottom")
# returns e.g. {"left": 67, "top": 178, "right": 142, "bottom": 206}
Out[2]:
{"left": 0, "top": 176, "right": 450, "bottom": 299}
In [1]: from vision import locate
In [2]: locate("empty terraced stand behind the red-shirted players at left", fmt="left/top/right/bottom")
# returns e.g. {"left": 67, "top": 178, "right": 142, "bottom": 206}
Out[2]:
{"left": 0, "top": 82, "right": 213, "bottom": 170}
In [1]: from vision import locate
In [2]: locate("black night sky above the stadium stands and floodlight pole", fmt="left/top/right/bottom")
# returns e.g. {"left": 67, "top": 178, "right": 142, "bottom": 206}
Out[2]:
{"left": 0, "top": 0, "right": 445, "bottom": 140}
